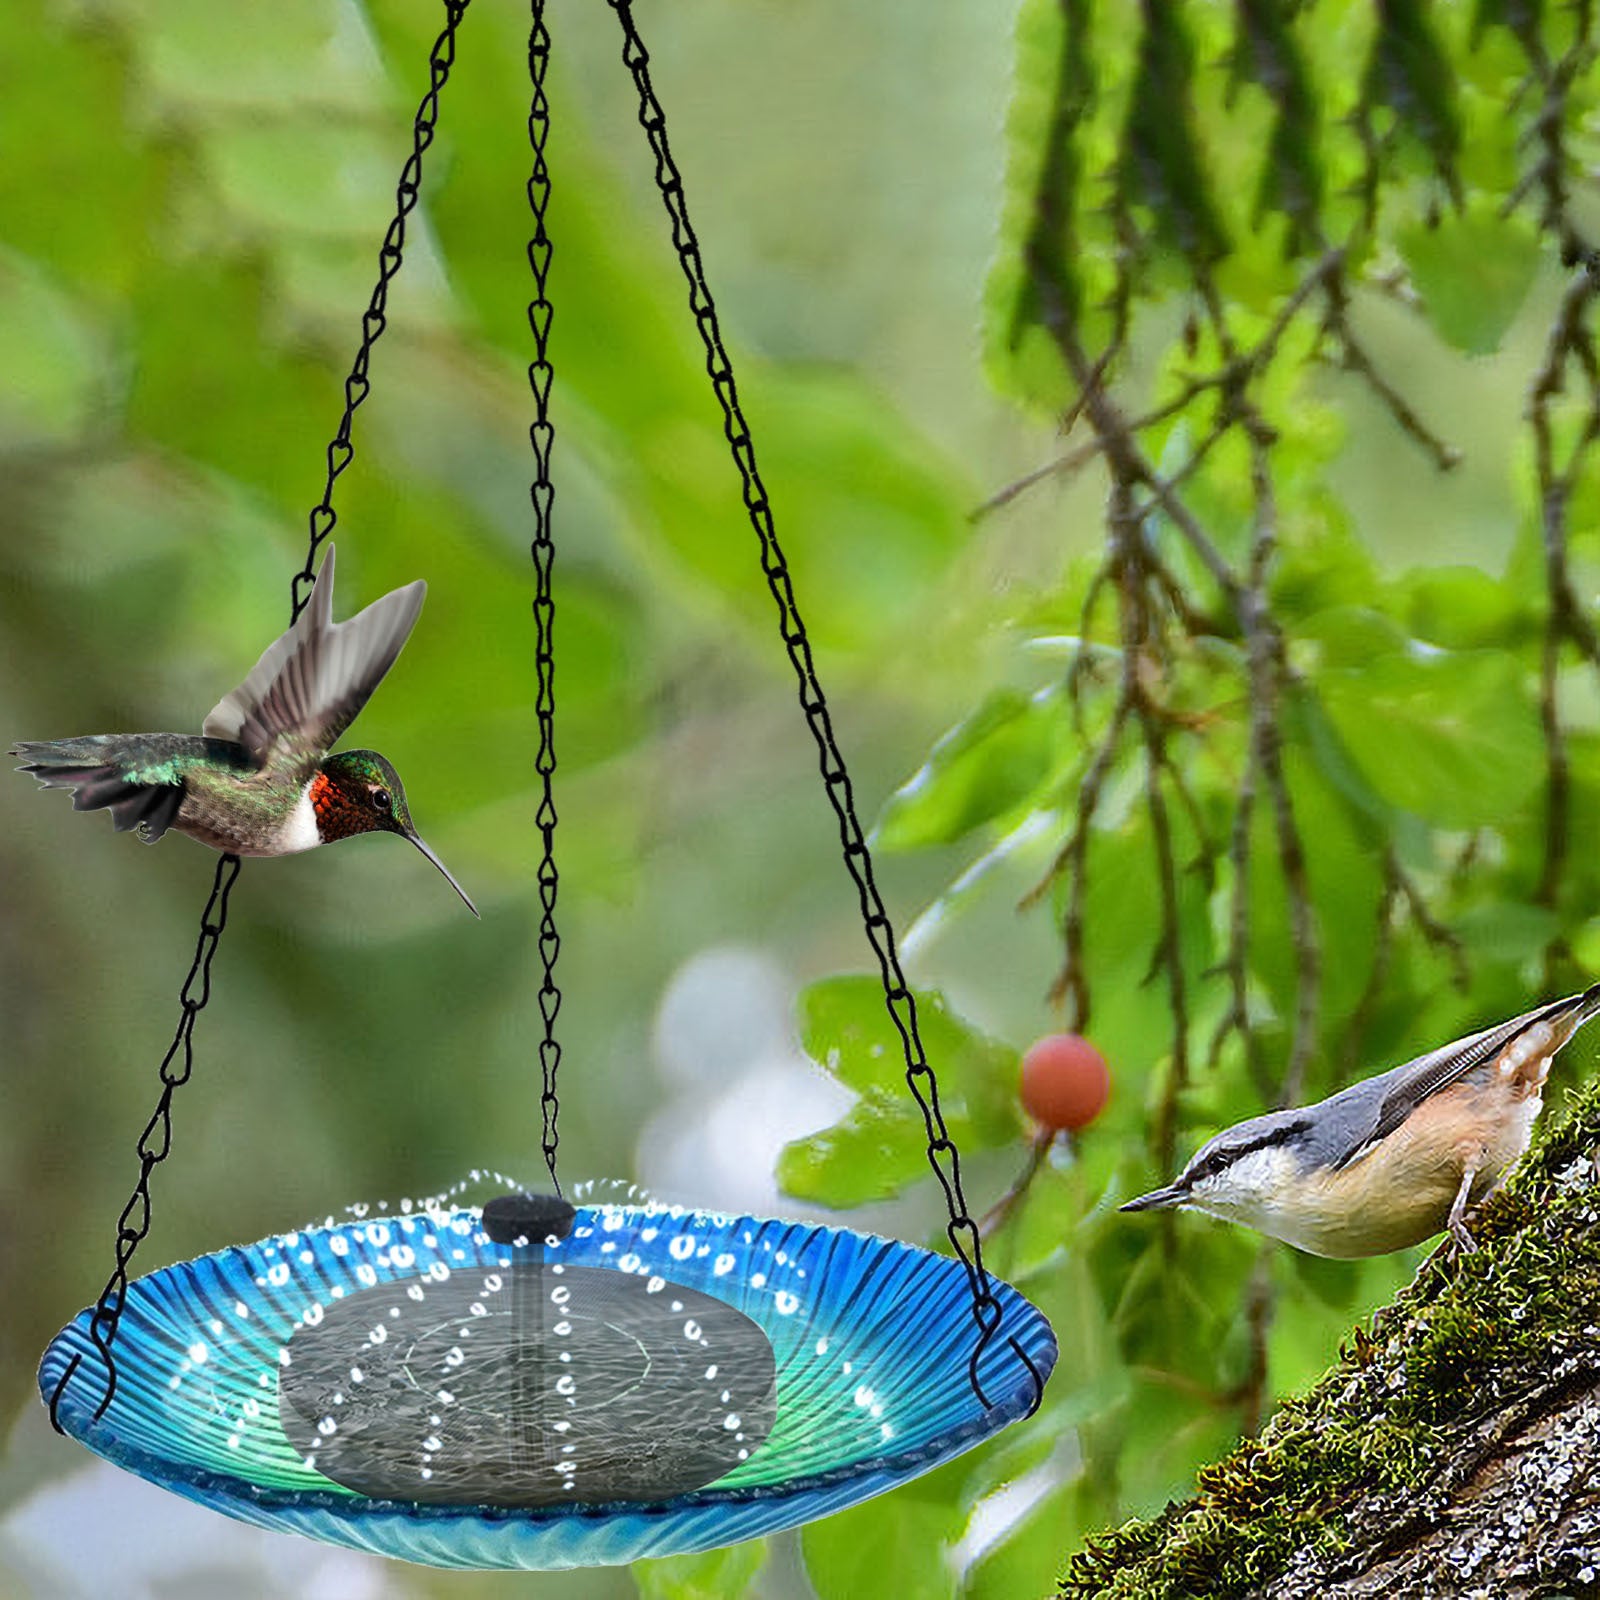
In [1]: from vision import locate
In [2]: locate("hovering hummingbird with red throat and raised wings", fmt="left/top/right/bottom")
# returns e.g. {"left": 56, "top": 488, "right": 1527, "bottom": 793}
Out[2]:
{"left": 11, "top": 544, "right": 478, "bottom": 917}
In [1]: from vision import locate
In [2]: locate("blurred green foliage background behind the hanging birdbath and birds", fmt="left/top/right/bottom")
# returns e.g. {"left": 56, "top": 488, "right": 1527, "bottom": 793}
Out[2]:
{"left": 0, "top": 0, "right": 1600, "bottom": 1600}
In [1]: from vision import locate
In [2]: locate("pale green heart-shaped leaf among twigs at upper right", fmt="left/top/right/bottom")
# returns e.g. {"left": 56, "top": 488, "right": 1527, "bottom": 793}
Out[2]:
{"left": 1398, "top": 205, "right": 1544, "bottom": 355}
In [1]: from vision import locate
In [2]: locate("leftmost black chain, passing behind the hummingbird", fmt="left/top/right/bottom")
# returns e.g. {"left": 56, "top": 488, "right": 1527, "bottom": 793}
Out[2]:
{"left": 50, "top": 0, "right": 470, "bottom": 1434}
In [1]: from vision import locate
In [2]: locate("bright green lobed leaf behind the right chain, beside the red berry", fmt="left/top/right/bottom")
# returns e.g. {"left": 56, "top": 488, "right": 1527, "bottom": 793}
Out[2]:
{"left": 778, "top": 978, "right": 1022, "bottom": 1208}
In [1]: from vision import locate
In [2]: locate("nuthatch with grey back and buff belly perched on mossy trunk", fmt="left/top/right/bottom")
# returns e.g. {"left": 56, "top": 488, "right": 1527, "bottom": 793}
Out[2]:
{"left": 1122, "top": 984, "right": 1600, "bottom": 1258}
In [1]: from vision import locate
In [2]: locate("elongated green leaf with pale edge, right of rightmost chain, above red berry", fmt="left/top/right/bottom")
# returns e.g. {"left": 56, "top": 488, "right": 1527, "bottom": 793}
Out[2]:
{"left": 874, "top": 690, "right": 1066, "bottom": 850}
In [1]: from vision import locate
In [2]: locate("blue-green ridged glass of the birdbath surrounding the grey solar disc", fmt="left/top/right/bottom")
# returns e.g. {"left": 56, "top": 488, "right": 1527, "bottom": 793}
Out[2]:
{"left": 38, "top": 1206, "right": 1056, "bottom": 1570}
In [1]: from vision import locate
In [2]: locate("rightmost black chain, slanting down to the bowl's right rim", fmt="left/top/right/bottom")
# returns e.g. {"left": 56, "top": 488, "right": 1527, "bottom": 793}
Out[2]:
{"left": 610, "top": 0, "right": 1043, "bottom": 1410}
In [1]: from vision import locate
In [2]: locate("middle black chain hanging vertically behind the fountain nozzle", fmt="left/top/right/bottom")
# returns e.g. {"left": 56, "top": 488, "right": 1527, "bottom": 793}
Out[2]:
{"left": 528, "top": 0, "right": 562, "bottom": 1194}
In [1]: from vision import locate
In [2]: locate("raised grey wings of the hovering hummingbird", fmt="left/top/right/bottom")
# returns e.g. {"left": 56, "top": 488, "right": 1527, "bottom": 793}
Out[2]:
{"left": 203, "top": 544, "right": 427, "bottom": 766}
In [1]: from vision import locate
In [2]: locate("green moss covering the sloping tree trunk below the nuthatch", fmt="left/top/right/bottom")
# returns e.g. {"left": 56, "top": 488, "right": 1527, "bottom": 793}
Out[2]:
{"left": 1061, "top": 1083, "right": 1600, "bottom": 1600}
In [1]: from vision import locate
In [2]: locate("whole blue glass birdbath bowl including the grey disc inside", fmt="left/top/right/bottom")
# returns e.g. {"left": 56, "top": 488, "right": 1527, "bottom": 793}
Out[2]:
{"left": 38, "top": 1206, "right": 1056, "bottom": 1570}
